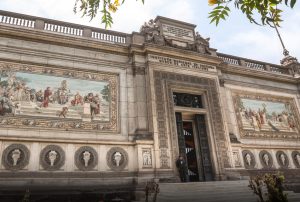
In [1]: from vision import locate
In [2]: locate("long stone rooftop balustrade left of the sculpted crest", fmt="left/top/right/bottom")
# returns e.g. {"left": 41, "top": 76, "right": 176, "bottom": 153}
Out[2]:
{"left": 0, "top": 10, "right": 127, "bottom": 44}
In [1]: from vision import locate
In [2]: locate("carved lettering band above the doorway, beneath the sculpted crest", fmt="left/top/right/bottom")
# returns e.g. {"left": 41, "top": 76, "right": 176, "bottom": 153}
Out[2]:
{"left": 148, "top": 54, "right": 217, "bottom": 72}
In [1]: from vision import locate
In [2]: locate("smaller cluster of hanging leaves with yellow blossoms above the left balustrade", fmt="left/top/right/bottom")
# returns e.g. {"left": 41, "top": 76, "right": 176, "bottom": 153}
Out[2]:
{"left": 73, "top": 0, "right": 144, "bottom": 28}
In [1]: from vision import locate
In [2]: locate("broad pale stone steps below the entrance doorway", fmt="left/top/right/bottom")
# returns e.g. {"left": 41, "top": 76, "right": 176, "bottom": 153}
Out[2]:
{"left": 157, "top": 180, "right": 300, "bottom": 202}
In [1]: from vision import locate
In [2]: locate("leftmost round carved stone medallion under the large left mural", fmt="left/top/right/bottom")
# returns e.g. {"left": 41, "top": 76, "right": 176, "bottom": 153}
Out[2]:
{"left": 2, "top": 144, "right": 30, "bottom": 170}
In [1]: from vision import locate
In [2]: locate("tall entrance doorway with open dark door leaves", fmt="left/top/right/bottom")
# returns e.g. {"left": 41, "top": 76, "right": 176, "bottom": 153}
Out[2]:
{"left": 176, "top": 112, "right": 213, "bottom": 182}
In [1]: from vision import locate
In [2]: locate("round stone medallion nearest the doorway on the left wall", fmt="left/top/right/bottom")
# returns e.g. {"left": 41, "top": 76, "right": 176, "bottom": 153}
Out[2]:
{"left": 106, "top": 147, "right": 128, "bottom": 171}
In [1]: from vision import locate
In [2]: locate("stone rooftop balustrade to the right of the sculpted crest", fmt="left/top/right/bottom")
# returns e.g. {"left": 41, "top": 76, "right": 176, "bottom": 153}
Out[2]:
{"left": 217, "top": 53, "right": 291, "bottom": 75}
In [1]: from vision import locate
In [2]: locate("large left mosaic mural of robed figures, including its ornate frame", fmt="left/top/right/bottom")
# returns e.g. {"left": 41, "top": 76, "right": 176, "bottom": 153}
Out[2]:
{"left": 0, "top": 62, "right": 117, "bottom": 129}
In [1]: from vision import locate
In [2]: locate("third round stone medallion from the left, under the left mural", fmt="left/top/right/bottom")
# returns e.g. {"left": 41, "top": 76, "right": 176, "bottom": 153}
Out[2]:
{"left": 75, "top": 146, "right": 98, "bottom": 171}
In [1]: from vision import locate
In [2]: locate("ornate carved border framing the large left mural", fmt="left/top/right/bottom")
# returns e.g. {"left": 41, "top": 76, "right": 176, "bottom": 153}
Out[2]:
{"left": 0, "top": 62, "right": 118, "bottom": 131}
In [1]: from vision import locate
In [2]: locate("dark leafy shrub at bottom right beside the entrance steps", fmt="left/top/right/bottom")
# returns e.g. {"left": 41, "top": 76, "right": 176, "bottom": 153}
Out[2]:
{"left": 249, "top": 173, "right": 288, "bottom": 202}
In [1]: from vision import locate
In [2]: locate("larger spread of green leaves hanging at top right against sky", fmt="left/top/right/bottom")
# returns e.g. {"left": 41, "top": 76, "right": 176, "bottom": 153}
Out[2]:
{"left": 208, "top": 0, "right": 297, "bottom": 27}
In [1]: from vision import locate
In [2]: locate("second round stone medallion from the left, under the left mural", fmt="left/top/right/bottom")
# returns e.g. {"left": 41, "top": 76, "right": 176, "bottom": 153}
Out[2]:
{"left": 40, "top": 145, "right": 65, "bottom": 171}
